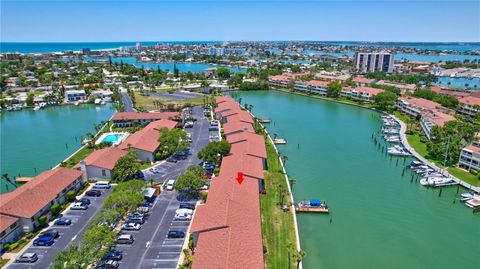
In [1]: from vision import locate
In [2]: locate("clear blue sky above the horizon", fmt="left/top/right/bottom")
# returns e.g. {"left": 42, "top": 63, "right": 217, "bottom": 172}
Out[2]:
{"left": 0, "top": 0, "right": 480, "bottom": 42}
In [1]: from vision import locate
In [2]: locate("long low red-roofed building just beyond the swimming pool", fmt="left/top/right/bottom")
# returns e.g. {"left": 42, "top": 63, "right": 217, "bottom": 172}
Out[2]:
{"left": 112, "top": 112, "right": 180, "bottom": 128}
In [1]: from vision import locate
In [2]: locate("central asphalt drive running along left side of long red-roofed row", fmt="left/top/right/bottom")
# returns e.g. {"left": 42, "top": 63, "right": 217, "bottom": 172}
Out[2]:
{"left": 116, "top": 107, "right": 209, "bottom": 269}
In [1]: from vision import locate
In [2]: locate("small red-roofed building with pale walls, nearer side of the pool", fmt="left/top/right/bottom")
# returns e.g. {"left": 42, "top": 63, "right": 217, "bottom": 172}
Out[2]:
{"left": 75, "top": 147, "right": 128, "bottom": 179}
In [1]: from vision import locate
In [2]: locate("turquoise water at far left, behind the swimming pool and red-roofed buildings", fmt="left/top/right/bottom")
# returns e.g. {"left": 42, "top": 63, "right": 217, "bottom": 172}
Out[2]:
{"left": 0, "top": 104, "right": 115, "bottom": 193}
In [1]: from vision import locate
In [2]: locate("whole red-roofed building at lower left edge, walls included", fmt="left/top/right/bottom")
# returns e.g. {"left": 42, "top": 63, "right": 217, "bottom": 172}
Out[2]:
{"left": 0, "top": 167, "right": 83, "bottom": 249}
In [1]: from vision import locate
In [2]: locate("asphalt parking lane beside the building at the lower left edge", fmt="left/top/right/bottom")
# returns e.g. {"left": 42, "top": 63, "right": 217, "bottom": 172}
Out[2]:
{"left": 8, "top": 187, "right": 111, "bottom": 269}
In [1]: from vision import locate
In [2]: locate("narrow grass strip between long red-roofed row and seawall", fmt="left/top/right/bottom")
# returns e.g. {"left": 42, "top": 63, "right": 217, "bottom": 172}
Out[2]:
{"left": 260, "top": 137, "right": 296, "bottom": 268}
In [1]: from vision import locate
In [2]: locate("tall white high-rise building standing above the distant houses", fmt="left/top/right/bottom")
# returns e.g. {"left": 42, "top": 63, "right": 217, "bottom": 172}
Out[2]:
{"left": 354, "top": 52, "right": 394, "bottom": 73}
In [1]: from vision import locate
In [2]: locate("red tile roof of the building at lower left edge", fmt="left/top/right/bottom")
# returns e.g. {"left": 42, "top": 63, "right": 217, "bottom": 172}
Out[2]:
{"left": 0, "top": 167, "right": 82, "bottom": 218}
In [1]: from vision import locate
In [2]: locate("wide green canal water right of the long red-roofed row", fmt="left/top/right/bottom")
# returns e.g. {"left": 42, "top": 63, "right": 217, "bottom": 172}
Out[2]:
{"left": 233, "top": 91, "right": 480, "bottom": 269}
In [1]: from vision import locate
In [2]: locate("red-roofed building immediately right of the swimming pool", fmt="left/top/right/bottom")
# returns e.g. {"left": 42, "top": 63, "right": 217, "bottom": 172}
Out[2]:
{"left": 118, "top": 120, "right": 178, "bottom": 162}
